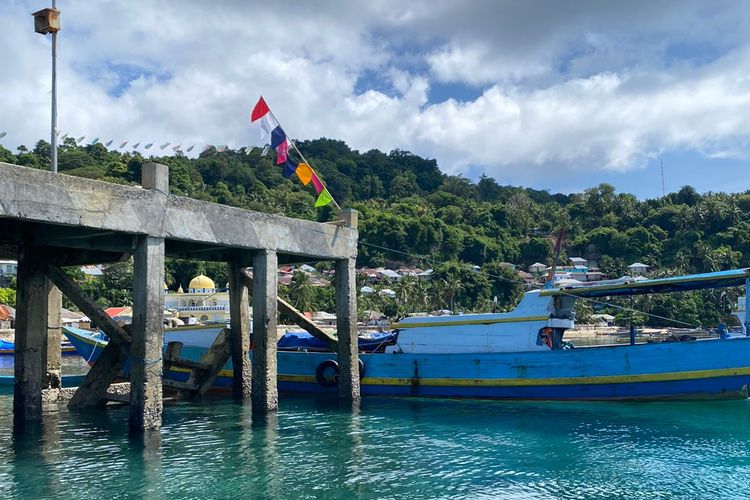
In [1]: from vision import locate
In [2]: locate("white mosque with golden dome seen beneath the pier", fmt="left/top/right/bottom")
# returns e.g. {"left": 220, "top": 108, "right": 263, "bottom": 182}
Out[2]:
{"left": 164, "top": 274, "right": 229, "bottom": 325}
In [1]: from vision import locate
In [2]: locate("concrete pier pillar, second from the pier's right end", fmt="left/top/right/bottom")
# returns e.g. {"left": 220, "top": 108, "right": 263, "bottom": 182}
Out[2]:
{"left": 252, "top": 250, "right": 279, "bottom": 412}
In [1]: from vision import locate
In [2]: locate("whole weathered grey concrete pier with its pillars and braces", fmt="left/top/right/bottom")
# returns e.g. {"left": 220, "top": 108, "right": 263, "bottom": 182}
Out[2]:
{"left": 0, "top": 163, "right": 359, "bottom": 431}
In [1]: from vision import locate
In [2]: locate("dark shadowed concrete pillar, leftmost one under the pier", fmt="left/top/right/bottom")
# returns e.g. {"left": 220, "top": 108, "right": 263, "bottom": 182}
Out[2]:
{"left": 13, "top": 249, "right": 48, "bottom": 427}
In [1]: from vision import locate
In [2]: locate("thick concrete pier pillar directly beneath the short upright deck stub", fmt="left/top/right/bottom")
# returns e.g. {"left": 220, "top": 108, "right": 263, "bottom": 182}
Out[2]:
{"left": 130, "top": 236, "right": 164, "bottom": 432}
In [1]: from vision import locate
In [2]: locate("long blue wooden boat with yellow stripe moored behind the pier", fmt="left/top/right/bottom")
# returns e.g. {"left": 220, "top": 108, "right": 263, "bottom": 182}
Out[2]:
{"left": 65, "top": 268, "right": 750, "bottom": 400}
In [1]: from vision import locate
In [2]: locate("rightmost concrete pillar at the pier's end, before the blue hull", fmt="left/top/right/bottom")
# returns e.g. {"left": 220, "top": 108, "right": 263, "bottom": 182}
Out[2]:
{"left": 336, "top": 258, "right": 360, "bottom": 401}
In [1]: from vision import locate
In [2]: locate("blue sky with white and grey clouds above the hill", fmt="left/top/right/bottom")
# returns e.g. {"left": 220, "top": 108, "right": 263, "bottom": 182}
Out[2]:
{"left": 0, "top": 0, "right": 750, "bottom": 198}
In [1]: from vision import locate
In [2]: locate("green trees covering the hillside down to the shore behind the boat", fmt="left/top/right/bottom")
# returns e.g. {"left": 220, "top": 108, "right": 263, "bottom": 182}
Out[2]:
{"left": 0, "top": 138, "right": 750, "bottom": 327}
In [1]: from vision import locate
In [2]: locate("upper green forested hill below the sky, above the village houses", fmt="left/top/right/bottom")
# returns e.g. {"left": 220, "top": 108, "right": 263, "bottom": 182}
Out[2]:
{"left": 0, "top": 139, "right": 750, "bottom": 324}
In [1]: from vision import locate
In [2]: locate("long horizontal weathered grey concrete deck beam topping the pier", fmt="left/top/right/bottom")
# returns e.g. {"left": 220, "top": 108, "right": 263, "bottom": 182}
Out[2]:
{"left": 0, "top": 163, "right": 357, "bottom": 259}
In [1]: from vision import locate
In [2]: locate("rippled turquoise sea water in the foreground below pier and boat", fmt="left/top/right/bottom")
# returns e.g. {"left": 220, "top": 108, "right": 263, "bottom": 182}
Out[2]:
{"left": 0, "top": 395, "right": 750, "bottom": 499}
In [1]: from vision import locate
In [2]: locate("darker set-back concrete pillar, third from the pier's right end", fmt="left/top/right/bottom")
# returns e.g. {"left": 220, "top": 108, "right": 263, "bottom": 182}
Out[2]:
{"left": 229, "top": 257, "right": 252, "bottom": 400}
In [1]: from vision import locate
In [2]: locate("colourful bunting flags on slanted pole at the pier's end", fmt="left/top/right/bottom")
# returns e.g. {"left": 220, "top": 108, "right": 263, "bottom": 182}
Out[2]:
{"left": 250, "top": 96, "right": 341, "bottom": 209}
